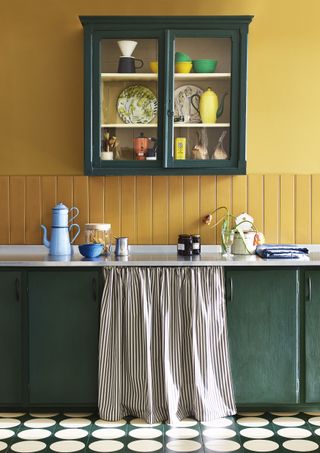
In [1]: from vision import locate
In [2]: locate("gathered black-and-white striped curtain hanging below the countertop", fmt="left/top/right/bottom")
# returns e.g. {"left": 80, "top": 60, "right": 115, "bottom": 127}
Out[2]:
{"left": 99, "top": 266, "right": 236, "bottom": 423}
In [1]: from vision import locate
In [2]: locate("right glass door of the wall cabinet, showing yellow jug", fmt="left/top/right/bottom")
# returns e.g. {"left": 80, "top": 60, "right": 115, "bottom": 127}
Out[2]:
{"left": 166, "top": 30, "right": 239, "bottom": 168}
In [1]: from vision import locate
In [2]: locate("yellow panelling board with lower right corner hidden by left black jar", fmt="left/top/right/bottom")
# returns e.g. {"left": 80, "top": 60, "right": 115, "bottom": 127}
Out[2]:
{"left": 168, "top": 176, "right": 183, "bottom": 244}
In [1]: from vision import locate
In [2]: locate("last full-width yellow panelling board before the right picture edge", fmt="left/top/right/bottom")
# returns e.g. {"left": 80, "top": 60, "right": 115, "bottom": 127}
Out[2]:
{"left": 295, "top": 175, "right": 312, "bottom": 244}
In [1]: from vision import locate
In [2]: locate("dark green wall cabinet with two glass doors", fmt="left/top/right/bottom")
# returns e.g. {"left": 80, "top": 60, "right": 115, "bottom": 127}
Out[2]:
{"left": 80, "top": 16, "right": 252, "bottom": 175}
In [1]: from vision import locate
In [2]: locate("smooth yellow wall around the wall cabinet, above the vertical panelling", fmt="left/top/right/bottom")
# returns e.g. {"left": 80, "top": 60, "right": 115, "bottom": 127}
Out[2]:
{"left": 0, "top": 0, "right": 320, "bottom": 175}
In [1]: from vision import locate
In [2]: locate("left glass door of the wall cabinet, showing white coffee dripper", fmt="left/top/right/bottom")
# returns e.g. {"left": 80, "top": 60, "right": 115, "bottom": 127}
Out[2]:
{"left": 93, "top": 33, "right": 162, "bottom": 169}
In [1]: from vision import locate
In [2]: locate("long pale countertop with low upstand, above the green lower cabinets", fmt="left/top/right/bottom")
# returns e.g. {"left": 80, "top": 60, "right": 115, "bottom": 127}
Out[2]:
{"left": 0, "top": 245, "right": 320, "bottom": 267}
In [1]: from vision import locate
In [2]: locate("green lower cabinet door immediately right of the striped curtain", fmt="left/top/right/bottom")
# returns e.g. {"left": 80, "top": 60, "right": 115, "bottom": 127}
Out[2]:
{"left": 226, "top": 268, "right": 298, "bottom": 407}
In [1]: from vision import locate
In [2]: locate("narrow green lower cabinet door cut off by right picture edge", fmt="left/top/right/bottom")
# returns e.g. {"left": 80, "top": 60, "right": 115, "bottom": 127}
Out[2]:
{"left": 305, "top": 270, "right": 320, "bottom": 403}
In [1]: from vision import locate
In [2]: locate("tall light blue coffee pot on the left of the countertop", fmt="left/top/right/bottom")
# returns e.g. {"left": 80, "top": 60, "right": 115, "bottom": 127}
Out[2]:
{"left": 41, "top": 203, "right": 80, "bottom": 255}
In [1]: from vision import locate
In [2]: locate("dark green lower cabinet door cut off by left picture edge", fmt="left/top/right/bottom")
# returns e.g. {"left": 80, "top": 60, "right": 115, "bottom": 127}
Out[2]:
{"left": 0, "top": 270, "right": 23, "bottom": 407}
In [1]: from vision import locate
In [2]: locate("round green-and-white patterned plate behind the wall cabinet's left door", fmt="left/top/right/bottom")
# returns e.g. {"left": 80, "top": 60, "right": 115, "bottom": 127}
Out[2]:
{"left": 117, "top": 85, "right": 158, "bottom": 124}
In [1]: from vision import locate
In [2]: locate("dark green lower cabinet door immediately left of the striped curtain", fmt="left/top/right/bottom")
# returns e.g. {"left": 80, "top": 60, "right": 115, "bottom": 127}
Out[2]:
{"left": 28, "top": 269, "right": 100, "bottom": 407}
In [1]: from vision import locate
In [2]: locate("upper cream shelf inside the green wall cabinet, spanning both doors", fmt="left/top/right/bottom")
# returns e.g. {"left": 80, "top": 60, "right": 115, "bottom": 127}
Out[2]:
{"left": 101, "top": 72, "right": 231, "bottom": 82}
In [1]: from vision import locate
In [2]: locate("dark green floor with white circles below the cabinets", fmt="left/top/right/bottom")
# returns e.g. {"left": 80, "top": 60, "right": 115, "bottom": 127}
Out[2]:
{"left": 0, "top": 412, "right": 320, "bottom": 453}
